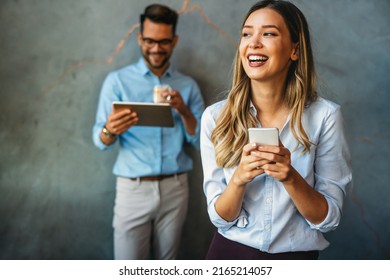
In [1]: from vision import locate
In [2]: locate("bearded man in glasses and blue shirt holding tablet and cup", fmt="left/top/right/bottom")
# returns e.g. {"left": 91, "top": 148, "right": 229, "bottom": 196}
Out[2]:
{"left": 93, "top": 4, "right": 204, "bottom": 259}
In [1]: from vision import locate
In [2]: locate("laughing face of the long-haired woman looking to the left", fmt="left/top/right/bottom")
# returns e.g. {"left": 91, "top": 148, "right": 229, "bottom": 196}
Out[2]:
{"left": 239, "top": 8, "right": 298, "bottom": 82}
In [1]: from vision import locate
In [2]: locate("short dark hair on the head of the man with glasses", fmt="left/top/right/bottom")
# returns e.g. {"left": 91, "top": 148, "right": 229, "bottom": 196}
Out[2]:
{"left": 140, "top": 4, "right": 179, "bottom": 34}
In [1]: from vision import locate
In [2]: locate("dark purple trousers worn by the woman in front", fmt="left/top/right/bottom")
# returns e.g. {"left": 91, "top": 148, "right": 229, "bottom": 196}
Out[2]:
{"left": 206, "top": 232, "right": 319, "bottom": 260}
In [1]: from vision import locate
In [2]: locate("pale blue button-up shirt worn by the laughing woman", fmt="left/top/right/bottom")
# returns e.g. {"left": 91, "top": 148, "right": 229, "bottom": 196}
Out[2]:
{"left": 201, "top": 98, "right": 352, "bottom": 253}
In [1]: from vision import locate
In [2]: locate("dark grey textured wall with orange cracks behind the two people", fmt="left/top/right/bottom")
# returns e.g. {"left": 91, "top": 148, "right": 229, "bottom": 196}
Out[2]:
{"left": 0, "top": 0, "right": 390, "bottom": 259}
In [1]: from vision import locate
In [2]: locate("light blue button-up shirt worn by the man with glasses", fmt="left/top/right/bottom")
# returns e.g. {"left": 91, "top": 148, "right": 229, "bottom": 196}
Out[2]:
{"left": 92, "top": 58, "right": 204, "bottom": 178}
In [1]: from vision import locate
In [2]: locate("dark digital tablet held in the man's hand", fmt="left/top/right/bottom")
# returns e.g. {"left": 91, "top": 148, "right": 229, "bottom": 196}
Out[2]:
{"left": 112, "top": 101, "right": 174, "bottom": 127}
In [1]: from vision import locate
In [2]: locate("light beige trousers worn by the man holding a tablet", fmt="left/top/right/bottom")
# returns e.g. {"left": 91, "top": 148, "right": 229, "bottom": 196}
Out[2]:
{"left": 113, "top": 174, "right": 188, "bottom": 260}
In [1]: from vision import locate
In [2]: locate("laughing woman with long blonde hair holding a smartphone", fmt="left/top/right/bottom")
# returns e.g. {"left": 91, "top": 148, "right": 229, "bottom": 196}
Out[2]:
{"left": 201, "top": 1, "right": 352, "bottom": 259}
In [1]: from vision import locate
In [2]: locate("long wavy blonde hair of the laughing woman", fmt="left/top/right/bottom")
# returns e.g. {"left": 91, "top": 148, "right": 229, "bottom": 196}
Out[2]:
{"left": 211, "top": 0, "right": 317, "bottom": 168}
